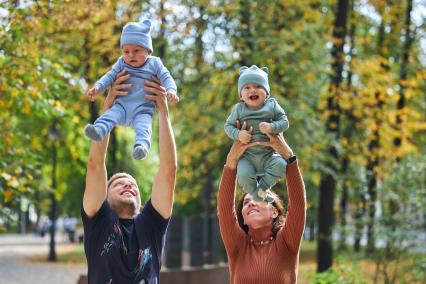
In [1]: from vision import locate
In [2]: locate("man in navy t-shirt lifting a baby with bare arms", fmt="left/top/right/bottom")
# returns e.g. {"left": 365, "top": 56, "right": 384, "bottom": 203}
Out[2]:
{"left": 82, "top": 73, "right": 177, "bottom": 284}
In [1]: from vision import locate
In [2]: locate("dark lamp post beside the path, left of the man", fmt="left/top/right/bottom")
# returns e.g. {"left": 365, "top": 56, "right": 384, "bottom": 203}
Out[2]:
{"left": 47, "top": 120, "right": 61, "bottom": 261}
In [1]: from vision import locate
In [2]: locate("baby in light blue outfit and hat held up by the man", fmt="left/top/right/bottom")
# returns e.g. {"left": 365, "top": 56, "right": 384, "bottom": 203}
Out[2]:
{"left": 84, "top": 20, "right": 179, "bottom": 160}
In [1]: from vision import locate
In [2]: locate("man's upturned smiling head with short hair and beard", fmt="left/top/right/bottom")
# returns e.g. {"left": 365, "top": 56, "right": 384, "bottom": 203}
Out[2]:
{"left": 107, "top": 176, "right": 141, "bottom": 218}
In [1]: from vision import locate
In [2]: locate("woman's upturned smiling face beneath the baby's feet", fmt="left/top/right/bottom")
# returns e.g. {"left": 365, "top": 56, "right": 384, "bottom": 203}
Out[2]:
{"left": 241, "top": 194, "right": 278, "bottom": 229}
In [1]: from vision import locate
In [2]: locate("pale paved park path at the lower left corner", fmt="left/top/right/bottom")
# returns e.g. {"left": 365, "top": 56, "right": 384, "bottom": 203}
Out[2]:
{"left": 0, "top": 235, "right": 87, "bottom": 284}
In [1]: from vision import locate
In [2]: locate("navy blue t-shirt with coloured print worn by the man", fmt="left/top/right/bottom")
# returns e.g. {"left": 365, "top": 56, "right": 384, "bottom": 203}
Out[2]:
{"left": 81, "top": 200, "right": 170, "bottom": 284}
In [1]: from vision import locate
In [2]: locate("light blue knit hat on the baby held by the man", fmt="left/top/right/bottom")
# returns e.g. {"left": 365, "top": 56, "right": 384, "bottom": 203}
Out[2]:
{"left": 120, "top": 20, "right": 153, "bottom": 53}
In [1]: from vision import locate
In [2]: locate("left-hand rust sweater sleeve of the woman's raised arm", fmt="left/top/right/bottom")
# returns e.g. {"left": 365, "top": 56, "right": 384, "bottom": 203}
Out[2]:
{"left": 217, "top": 166, "right": 245, "bottom": 255}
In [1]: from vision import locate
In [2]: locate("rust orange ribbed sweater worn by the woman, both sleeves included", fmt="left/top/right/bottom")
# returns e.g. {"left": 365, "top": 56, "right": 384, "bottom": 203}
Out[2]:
{"left": 217, "top": 160, "right": 306, "bottom": 284}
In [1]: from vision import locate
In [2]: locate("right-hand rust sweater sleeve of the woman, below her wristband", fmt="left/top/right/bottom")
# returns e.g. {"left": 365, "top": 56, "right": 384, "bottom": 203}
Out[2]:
{"left": 277, "top": 160, "right": 306, "bottom": 252}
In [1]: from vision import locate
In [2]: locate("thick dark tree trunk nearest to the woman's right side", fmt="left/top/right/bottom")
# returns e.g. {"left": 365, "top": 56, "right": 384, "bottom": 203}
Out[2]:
{"left": 317, "top": 0, "right": 349, "bottom": 272}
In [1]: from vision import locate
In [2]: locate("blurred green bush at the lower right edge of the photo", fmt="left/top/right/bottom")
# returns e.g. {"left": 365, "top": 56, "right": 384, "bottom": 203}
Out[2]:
{"left": 373, "top": 155, "right": 426, "bottom": 283}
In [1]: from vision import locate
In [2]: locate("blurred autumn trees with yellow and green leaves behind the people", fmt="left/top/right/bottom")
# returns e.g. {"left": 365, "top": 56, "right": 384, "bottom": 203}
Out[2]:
{"left": 0, "top": 0, "right": 426, "bottom": 277}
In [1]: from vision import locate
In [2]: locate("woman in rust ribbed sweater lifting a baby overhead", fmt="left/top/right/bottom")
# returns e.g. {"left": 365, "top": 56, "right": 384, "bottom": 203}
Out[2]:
{"left": 218, "top": 127, "right": 306, "bottom": 284}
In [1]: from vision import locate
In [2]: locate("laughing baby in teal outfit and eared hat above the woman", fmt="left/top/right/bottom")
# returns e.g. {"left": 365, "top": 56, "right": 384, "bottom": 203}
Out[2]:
{"left": 225, "top": 65, "right": 289, "bottom": 202}
